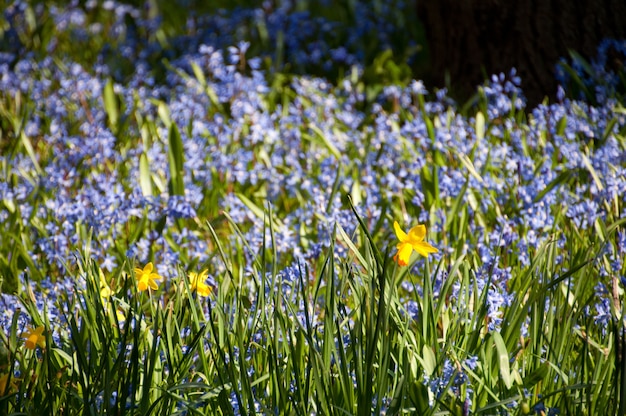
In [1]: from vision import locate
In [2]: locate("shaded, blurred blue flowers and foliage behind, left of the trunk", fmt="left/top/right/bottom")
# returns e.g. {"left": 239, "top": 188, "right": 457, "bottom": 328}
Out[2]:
{"left": 0, "top": 0, "right": 428, "bottom": 91}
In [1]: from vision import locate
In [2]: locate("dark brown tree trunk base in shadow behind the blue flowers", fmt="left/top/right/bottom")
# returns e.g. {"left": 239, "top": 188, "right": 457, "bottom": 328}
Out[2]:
{"left": 417, "top": 0, "right": 626, "bottom": 106}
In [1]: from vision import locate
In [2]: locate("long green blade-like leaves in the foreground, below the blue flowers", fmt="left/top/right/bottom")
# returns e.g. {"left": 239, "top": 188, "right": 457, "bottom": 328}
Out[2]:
{"left": 0, "top": 197, "right": 617, "bottom": 415}
